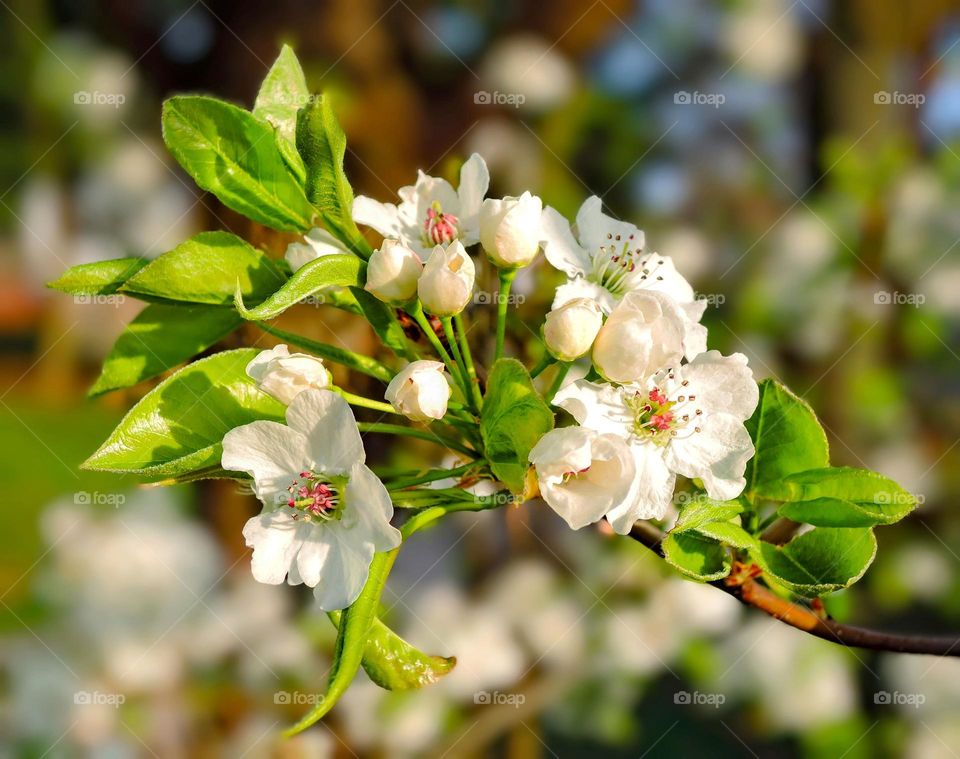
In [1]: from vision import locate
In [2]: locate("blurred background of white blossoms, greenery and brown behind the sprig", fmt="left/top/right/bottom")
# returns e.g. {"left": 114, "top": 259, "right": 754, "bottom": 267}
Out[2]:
{"left": 0, "top": 0, "right": 960, "bottom": 759}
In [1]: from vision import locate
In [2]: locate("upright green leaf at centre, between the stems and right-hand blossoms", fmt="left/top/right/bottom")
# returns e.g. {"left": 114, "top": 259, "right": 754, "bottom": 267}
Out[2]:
{"left": 480, "top": 358, "right": 553, "bottom": 493}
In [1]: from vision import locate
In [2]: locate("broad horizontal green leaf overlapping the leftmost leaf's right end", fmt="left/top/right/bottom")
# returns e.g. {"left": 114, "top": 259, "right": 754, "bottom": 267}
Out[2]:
{"left": 121, "top": 232, "right": 287, "bottom": 305}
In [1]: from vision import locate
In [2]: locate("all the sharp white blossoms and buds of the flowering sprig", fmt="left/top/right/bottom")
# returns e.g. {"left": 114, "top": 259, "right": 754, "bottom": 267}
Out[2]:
{"left": 222, "top": 154, "right": 758, "bottom": 610}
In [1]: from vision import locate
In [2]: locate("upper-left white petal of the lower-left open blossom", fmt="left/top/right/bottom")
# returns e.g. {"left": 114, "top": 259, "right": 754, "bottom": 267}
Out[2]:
{"left": 220, "top": 419, "right": 311, "bottom": 506}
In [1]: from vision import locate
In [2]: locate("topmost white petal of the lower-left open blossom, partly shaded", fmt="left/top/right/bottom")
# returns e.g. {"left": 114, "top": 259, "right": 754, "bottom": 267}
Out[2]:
{"left": 287, "top": 390, "right": 366, "bottom": 474}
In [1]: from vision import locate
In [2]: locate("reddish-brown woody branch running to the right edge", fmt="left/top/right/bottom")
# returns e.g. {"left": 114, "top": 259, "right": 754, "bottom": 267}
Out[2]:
{"left": 630, "top": 522, "right": 960, "bottom": 657}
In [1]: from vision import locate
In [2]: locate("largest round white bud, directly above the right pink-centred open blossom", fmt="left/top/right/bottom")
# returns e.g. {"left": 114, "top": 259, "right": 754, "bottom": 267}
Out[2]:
{"left": 593, "top": 290, "right": 684, "bottom": 382}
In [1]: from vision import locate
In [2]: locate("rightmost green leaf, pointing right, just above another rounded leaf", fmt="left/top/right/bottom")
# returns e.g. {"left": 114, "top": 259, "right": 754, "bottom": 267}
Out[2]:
{"left": 757, "top": 467, "right": 917, "bottom": 527}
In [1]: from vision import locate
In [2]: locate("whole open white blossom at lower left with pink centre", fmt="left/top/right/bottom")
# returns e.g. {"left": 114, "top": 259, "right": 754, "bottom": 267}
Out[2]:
{"left": 222, "top": 389, "right": 400, "bottom": 611}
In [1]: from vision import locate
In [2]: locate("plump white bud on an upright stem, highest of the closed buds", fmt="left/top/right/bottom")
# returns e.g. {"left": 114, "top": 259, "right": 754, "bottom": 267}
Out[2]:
{"left": 480, "top": 192, "right": 543, "bottom": 269}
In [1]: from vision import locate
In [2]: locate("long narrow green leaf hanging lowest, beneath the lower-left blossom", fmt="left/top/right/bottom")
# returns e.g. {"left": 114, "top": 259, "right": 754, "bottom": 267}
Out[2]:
{"left": 283, "top": 548, "right": 399, "bottom": 737}
